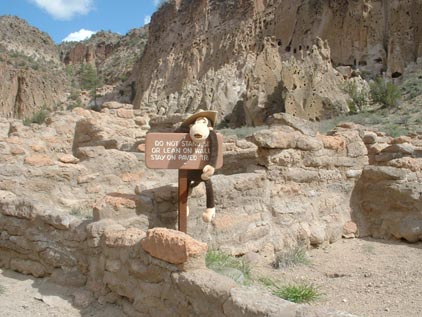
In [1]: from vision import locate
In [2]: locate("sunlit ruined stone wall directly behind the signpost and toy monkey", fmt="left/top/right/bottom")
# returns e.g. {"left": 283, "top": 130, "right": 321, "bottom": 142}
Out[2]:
{"left": 86, "top": 114, "right": 368, "bottom": 254}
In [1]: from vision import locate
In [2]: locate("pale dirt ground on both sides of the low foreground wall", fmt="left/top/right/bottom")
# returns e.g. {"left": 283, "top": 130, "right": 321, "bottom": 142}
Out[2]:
{"left": 0, "top": 239, "right": 422, "bottom": 317}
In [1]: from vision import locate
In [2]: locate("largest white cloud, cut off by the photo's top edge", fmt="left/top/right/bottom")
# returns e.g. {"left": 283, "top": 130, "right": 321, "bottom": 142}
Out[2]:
{"left": 30, "top": 0, "right": 94, "bottom": 20}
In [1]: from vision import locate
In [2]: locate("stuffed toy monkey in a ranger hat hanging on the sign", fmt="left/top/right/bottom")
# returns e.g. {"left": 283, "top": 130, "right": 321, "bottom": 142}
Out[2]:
{"left": 175, "top": 110, "right": 218, "bottom": 222}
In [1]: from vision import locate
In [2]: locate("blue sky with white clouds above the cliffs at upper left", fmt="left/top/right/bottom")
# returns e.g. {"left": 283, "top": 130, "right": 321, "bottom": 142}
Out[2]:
{"left": 0, "top": 0, "right": 160, "bottom": 43}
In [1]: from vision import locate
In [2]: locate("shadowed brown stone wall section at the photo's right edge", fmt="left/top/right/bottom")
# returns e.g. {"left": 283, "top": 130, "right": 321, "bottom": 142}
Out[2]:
{"left": 352, "top": 127, "right": 422, "bottom": 242}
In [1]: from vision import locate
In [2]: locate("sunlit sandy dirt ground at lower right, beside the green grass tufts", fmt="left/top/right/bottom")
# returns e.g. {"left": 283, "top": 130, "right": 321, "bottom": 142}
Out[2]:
{"left": 254, "top": 239, "right": 422, "bottom": 317}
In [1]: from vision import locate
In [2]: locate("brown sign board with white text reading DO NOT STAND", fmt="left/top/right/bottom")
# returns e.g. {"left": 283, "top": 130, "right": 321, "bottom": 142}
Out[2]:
{"left": 145, "top": 133, "right": 223, "bottom": 170}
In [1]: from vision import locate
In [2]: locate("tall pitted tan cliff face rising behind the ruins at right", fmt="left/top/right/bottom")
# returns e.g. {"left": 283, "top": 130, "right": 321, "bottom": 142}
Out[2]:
{"left": 134, "top": 0, "right": 422, "bottom": 125}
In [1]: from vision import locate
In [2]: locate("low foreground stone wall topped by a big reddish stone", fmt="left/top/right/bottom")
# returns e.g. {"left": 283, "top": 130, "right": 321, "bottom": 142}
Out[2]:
{"left": 0, "top": 204, "right": 351, "bottom": 317}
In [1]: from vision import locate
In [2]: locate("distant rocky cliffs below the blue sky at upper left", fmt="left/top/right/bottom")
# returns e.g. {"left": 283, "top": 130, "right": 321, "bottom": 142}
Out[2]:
{"left": 0, "top": 16, "right": 148, "bottom": 118}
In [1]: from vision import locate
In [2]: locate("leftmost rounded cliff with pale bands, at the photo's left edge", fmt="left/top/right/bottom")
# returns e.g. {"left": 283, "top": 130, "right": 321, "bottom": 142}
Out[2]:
{"left": 0, "top": 16, "right": 67, "bottom": 118}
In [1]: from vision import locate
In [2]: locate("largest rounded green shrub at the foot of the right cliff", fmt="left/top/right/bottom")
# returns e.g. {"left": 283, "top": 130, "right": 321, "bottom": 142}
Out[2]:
{"left": 369, "top": 77, "right": 401, "bottom": 108}
